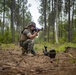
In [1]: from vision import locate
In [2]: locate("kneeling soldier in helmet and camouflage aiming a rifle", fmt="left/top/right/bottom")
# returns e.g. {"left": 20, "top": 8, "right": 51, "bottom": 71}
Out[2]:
{"left": 20, "top": 22, "right": 39, "bottom": 55}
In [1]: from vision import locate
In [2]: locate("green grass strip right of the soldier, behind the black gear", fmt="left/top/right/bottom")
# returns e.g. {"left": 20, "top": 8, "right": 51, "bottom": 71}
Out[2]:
{"left": 35, "top": 42, "right": 76, "bottom": 52}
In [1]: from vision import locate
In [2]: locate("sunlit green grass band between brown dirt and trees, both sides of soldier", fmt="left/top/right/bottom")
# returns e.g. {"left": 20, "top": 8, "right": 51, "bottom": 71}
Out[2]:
{"left": 2, "top": 42, "right": 76, "bottom": 52}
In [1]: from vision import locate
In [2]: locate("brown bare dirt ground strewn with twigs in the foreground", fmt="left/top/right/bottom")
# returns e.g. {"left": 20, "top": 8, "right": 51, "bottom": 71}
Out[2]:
{"left": 0, "top": 47, "right": 76, "bottom": 75}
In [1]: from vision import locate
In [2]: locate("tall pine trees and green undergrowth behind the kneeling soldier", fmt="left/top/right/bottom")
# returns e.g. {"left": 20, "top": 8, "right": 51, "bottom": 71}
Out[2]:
{"left": 0, "top": 0, "right": 76, "bottom": 44}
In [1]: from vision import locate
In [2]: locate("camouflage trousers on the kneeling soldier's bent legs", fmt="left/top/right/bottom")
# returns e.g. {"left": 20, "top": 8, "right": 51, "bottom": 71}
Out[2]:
{"left": 20, "top": 39, "right": 35, "bottom": 55}
